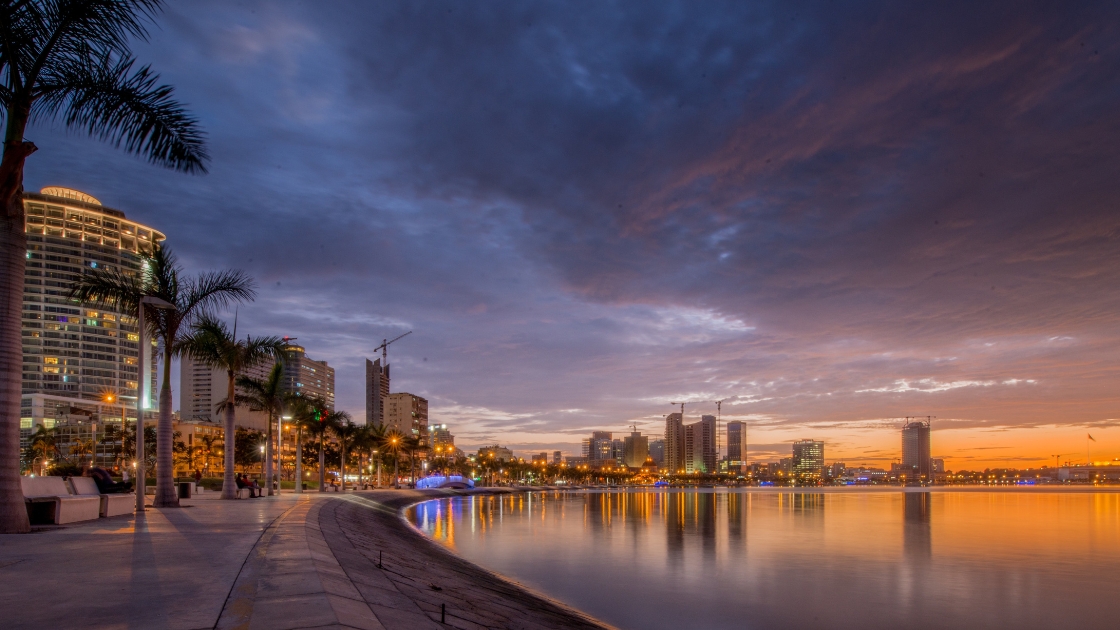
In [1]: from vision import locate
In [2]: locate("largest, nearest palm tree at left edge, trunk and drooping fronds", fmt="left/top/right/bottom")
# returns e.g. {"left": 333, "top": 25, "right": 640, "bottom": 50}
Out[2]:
{"left": 0, "top": 0, "right": 209, "bottom": 534}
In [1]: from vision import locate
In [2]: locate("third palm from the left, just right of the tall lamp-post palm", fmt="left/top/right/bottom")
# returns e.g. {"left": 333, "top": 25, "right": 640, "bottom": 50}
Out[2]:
{"left": 180, "top": 316, "right": 283, "bottom": 499}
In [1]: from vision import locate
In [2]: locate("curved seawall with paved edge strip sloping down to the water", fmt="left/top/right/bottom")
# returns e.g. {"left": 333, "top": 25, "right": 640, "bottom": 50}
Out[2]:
{"left": 217, "top": 490, "right": 609, "bottom": 629}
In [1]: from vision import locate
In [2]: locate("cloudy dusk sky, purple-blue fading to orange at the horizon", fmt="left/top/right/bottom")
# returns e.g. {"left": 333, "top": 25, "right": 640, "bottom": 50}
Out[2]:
{"left": 27, "top": 1, "right": 1120, "bottom": 470}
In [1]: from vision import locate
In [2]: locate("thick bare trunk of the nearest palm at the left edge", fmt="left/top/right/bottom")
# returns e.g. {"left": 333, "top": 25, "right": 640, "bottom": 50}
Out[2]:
{"left": 0, "top": 124, "right": 35, "bottom": 534}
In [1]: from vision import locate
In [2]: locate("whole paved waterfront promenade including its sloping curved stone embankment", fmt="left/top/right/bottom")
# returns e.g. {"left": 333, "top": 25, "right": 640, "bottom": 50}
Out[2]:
{"left": 0, "top": 490, "right": 604, "bottom": 629}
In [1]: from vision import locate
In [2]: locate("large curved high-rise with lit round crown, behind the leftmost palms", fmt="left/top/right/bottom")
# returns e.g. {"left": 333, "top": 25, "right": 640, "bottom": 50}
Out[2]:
{"left": 20, "top": 187, "right": 165, "bottom": 461}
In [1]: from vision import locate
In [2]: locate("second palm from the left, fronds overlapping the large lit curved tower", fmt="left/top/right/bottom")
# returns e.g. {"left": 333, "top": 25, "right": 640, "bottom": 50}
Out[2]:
{"left": 69, "top": 244, "right": 255, "bottom": 508}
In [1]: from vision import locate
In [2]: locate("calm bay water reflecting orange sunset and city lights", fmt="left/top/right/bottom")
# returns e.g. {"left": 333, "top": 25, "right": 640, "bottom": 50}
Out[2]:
{"left": 408, "top": 490, "right": 1120, "bottom": 630}
